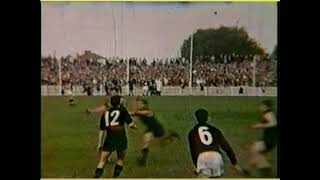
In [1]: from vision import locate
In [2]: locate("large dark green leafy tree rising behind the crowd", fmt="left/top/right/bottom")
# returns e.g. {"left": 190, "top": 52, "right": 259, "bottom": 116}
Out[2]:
{"left": 181, "top": 26, "right": 265, "bottom": 62}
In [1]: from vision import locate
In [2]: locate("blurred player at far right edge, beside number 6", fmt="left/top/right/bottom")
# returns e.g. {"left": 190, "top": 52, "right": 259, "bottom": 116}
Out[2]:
{"left": 249, "top": 100, "right": 278, "bottom": 176}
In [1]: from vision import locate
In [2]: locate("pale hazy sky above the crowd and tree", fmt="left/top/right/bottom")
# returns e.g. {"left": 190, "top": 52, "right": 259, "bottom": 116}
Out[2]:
{"left": 41, "top": 2, "right": 277, "bottom": 58}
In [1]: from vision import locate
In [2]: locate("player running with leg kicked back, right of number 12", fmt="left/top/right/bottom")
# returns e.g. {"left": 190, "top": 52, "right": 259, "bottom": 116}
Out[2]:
{"left": 130, "top": 98, "right": 179, "bottom": 166}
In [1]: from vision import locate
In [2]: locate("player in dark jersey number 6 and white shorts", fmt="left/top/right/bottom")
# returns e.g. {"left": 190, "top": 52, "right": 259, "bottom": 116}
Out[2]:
{"left": 188, "top": 109, "right": 242, "bottom": 177}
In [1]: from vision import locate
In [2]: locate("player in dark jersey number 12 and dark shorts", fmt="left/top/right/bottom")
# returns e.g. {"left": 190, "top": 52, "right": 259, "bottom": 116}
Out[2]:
{"left": 94, "top": 96, "right": 136, "bottom": 178}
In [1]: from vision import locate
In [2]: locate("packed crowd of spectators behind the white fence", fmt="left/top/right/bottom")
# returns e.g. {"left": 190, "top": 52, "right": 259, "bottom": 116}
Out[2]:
{"left": 41, "top": 56, "right": 275, "bottom": 87}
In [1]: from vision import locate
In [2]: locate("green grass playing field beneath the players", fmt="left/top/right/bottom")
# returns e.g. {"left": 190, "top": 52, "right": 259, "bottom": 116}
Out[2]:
{"left": 41, "top": 96, "right": 277, "bottom": 178}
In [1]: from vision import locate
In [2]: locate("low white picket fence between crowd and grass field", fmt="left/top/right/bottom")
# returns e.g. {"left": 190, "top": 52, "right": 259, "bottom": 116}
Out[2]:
{"left": 41, "top": 85, "right": 277, "bottom": 96}
